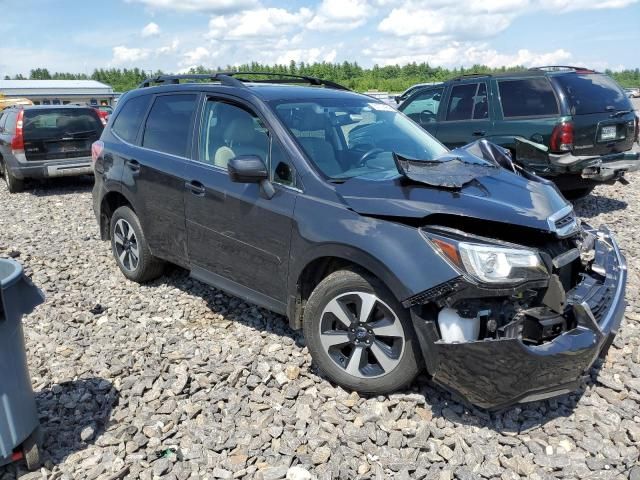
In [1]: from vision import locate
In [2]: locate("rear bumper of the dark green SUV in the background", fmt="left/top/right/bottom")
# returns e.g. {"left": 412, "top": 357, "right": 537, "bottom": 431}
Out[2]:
{"left": 515, "top": 137, "right": 640, "bottom": 183}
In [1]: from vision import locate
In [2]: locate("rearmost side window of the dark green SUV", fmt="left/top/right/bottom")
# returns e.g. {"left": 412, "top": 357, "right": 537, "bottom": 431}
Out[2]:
{"left": 498, "top": 77, "right": 559, "bottom": 118}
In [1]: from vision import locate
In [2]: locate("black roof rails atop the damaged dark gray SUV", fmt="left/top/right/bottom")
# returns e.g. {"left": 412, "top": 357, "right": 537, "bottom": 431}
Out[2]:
{"left": 138, "top": 72, "right": 349, "bottom": 90}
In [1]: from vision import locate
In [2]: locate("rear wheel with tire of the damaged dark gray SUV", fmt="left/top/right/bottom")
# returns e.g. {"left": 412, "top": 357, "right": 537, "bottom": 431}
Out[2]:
{"left": 109, "top": 207, "right": 164, "bottom": 283}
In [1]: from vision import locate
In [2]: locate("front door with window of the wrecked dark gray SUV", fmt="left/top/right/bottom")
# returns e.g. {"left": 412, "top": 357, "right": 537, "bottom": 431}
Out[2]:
{"left": 185, "top": 98, "right": 298, "bottom": 313}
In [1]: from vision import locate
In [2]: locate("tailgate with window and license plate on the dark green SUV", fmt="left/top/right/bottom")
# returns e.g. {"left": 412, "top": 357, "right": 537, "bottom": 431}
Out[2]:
{"left": 554, "top": 73, "right": 635, "bottom": 155}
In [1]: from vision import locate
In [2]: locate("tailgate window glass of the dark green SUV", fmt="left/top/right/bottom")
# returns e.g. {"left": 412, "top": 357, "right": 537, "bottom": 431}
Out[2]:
{"left": 556, "top": 74, "right": 632, "bottom": 115}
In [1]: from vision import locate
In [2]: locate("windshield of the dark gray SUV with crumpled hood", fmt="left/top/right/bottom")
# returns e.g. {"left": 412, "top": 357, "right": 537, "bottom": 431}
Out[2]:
{"left": 272, "top": 98, "right": 447, "bottom": 180}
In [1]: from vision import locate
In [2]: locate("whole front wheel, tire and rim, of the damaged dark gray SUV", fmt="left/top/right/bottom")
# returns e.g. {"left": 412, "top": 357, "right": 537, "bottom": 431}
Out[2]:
{"left": 303, "top": 270, "right": 421, "bottom": 395}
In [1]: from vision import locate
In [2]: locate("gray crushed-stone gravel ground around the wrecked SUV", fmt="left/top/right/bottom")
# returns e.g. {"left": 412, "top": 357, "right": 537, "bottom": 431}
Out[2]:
{"left": 0, "top": 170, "right": 640, "bottom": 480}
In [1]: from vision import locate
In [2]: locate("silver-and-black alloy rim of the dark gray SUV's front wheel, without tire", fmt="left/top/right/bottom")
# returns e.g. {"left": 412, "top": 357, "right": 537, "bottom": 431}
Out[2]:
{"left": 319, "top": 292, "right": 405, "bottom": 378}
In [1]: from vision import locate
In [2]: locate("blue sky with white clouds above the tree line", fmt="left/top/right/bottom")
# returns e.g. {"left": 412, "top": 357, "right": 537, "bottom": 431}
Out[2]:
{"left": 0, "top": 0, "right": 640, "bottom": 77}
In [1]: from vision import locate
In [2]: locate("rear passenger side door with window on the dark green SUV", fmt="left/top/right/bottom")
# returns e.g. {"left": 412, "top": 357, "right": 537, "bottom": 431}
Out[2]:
{"left": 436, "top": 81, "right": 492, "bottom": 148}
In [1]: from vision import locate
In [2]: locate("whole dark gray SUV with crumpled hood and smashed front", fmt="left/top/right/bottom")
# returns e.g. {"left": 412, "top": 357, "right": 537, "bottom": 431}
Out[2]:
{"left": 93, "top": 73, "right": 626, "bottom": 407}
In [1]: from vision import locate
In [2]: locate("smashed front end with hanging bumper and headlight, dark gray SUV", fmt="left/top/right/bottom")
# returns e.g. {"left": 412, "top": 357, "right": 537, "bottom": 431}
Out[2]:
{"left": 405, "top": 220, "right": 627, "bottom": 409}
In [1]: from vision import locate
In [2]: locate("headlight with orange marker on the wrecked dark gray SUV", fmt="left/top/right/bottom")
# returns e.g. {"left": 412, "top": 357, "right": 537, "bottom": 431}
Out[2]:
{"left": 423, "top": 230, "right": 548, "bottom": 285}
